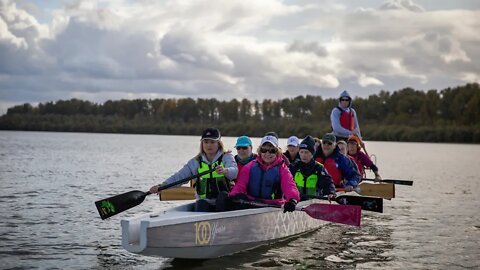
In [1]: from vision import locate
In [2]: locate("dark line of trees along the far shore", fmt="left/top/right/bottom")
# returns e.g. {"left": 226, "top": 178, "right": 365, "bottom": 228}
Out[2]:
{"left": 0, "top": 83, "right": 480, "bottom": 143}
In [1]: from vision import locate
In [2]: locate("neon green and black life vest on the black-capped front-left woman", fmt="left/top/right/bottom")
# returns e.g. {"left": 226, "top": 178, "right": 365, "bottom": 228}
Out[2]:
{"left": 195, "top": 155, "right": 230, "bottom": 199}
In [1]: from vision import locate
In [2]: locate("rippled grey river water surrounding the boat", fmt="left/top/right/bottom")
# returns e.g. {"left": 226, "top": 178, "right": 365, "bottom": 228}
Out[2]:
{"left": 0, "top": 131, "right": 480, "bottom": 269}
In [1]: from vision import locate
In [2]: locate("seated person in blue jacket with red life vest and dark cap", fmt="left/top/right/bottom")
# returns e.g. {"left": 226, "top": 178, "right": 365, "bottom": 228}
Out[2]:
{"left": 314, "top": 133, "right": 361, "bottom": 191}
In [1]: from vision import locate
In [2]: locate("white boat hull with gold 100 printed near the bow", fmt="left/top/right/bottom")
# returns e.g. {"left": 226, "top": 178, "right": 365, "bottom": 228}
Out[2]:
{"left": 121, "top": 201, "right": 326, "bottom": 259}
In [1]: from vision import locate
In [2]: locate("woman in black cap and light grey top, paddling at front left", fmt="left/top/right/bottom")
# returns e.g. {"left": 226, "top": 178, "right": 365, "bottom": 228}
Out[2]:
{"left": 150, "top": 128, "right": 238, "bottom": 212}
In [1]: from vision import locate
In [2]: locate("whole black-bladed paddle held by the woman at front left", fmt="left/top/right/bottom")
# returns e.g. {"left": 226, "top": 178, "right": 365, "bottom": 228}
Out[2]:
{"left": 95, "top": 168, "right": 215, "bottom": 219}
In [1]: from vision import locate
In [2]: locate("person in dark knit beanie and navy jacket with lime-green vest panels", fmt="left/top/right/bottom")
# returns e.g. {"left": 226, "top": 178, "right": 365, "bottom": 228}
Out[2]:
{"left": 289, "top": 135, "right": 335, "bottom": 201}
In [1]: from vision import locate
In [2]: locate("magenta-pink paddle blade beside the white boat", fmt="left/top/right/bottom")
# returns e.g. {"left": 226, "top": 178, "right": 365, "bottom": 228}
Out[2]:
{"left": 301, "top": 203, "right": 362, "bottom": 226}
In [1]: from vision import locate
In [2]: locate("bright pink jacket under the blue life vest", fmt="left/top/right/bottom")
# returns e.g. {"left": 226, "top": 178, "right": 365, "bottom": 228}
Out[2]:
{"left": 229, "top": 156, "right": 300, "bottom": 205}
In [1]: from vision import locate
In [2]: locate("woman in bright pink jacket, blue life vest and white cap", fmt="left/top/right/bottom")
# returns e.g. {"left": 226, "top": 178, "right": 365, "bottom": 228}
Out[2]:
{"left": 224, "top": 135, "right": 300, "bottom": 212}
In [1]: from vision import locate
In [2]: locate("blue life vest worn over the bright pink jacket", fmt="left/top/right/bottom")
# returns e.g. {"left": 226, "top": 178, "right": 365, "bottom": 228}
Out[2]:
{"left": 247, "top": 162, "right": 283, "bottom": 200}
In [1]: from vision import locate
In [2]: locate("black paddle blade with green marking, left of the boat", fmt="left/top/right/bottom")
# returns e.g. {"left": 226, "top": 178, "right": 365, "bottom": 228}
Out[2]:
{"left": 95, "top": 190, "right": 150, "bottom": 219}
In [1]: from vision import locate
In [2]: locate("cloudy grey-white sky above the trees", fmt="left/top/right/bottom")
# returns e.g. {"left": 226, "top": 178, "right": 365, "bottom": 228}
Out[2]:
{"left": 0, "top": 0, "right": 480, "bottom": 114}
